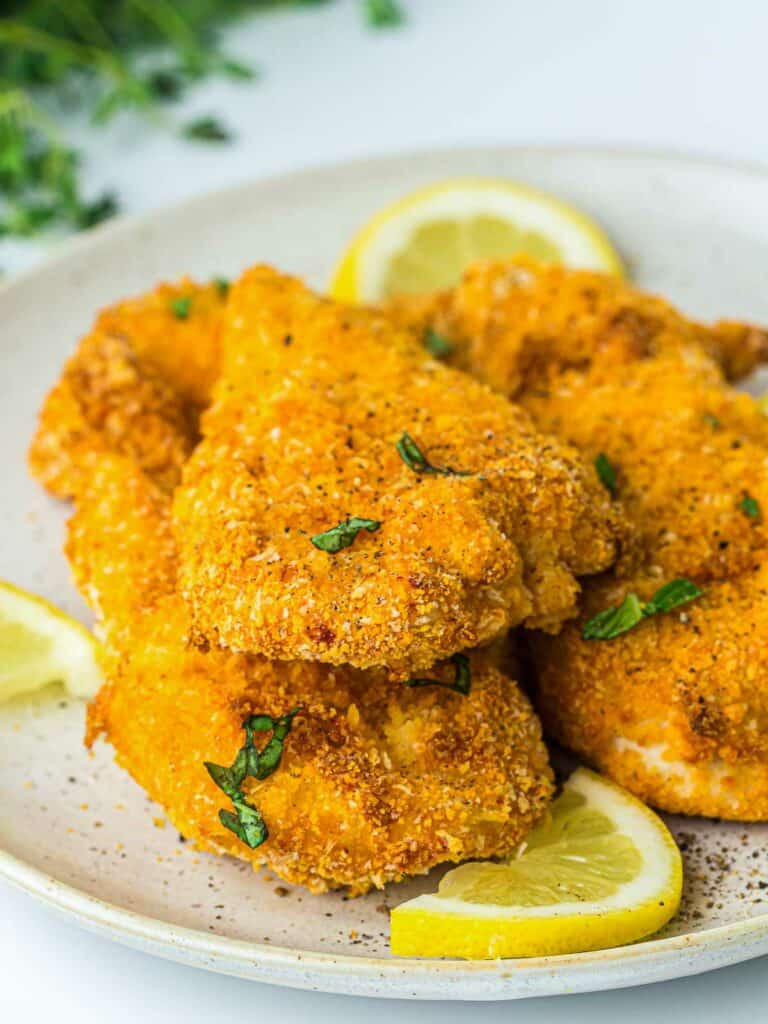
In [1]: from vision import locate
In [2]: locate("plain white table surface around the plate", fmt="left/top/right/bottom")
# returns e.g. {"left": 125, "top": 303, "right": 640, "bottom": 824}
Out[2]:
{"left": 0, "top": 0, "right": 768, "bottom": 1024}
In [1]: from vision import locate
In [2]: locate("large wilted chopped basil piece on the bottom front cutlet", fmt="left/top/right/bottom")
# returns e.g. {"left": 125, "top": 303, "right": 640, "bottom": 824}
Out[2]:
{"left": 204, "top": 708, "right": 301, "bottom": 850}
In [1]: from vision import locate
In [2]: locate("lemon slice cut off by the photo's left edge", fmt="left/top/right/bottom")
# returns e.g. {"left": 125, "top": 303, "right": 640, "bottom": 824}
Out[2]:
{"left": 0, "top": 581, "right": 101, "bottom": 701}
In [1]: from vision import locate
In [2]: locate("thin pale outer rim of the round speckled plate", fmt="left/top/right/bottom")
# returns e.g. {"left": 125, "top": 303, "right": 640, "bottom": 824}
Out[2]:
{"left": 0, "top": 142, "right": 768, "bottom": 998}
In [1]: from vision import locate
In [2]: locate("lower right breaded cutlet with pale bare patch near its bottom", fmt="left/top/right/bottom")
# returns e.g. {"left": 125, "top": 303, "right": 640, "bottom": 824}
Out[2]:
{"left": 532, "top": 566, "right": 768, "bottom": 821}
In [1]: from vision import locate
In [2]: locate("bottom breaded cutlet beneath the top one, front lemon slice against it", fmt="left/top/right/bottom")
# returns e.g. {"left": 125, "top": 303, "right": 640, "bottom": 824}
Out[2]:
{"left": 73, "top": 457, "right": 553, "bottom": 893}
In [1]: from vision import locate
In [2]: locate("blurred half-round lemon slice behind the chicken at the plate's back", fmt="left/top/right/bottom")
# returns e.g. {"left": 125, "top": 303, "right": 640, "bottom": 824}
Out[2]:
{"left": 331, "top": 178, "right": 624, "bottom": 302}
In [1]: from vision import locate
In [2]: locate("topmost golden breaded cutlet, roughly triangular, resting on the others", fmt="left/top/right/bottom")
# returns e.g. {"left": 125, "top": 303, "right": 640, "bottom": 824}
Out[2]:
{"left": 174, "top": 267, "right": 617, "bottom": 677}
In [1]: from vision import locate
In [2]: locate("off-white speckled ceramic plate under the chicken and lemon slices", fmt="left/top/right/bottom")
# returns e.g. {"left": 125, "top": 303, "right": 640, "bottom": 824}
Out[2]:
{"left": 0, "top": 148, "right": 768, "bottom": 999}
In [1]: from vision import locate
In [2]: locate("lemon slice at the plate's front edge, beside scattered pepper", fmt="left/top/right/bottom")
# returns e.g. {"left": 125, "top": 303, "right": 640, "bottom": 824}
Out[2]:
{"left": 391, "top": 768, "right": 683, "bottom": 959}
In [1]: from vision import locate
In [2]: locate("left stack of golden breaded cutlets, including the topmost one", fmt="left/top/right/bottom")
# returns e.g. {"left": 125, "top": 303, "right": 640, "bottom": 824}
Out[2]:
{"left": 31, "top": 268, "right": 617, "bottom": 893}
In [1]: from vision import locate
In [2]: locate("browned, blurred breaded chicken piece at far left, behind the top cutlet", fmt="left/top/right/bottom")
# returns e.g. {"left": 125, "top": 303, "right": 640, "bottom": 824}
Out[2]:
{"left": 29, "top": 280, "right": 223, "bottom": 498}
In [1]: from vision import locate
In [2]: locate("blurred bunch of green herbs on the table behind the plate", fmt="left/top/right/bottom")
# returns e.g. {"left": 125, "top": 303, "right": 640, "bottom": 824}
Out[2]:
{"left": 0, "top": 0, "right": 399, "bottom": 237}
